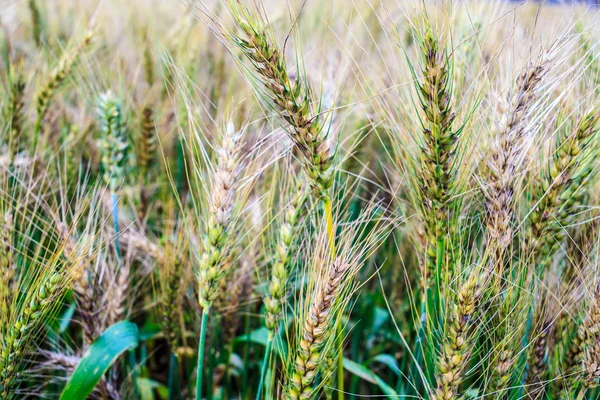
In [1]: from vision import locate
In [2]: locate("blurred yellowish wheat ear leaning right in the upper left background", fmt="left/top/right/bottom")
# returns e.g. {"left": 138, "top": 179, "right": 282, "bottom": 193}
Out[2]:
{"left": 32, "top": 31, "right": 94, "bottom": 153}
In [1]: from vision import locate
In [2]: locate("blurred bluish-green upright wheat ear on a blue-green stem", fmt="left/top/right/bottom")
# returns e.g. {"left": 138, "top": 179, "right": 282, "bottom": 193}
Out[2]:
{"left": 98, "top": 91, "right": 129, "bottom": 193}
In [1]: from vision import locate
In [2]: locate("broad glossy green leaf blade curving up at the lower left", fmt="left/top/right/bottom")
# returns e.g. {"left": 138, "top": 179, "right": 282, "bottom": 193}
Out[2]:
{"left": 60, "top": 321, "right": 140, "bottom": 400}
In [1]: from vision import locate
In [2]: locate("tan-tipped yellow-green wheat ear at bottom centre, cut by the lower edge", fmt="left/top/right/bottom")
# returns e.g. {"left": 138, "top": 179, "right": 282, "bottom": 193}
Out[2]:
{"left": 285, "top": 259, "right": 351, "bottom": 399}
